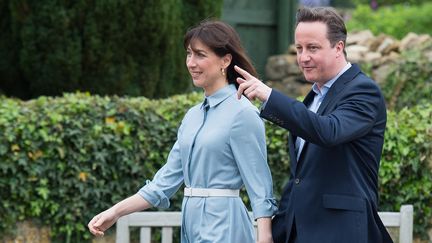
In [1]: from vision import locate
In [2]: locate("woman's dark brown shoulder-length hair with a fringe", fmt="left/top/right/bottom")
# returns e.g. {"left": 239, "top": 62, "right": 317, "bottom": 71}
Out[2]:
{"left": 183, "top": 20, "right": 257, "bottom": 88}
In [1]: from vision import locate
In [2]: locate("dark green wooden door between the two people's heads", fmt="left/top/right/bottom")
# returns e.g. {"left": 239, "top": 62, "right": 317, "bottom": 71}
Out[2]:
{"left": 222, "top": 0, "right": 296, "bottom": 79}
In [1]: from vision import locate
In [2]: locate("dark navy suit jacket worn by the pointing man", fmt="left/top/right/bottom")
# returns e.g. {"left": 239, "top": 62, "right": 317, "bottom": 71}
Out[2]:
{"left": 261, "top": 64, "right": 392, "bottom": 243}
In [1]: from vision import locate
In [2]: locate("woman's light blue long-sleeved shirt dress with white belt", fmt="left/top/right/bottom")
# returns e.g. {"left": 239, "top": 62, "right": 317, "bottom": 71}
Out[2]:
{"left": 138, "top": 84, "right": 277, "bottom": 243}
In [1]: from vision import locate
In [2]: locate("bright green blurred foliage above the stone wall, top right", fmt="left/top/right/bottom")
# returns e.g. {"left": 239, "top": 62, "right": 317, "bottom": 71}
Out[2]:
{"left": 347, "top": 2, "right": 432, "bottom": 39}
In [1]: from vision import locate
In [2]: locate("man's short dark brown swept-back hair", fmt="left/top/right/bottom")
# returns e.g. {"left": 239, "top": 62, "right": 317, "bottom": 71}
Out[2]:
{"left": 296, "top": 7, "right": 347, "bottom": 56}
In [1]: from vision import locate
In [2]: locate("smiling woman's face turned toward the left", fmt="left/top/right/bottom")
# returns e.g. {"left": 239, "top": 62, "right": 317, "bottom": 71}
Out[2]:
{"left": 186, "top": 40, "right": 231, "bottom": 96}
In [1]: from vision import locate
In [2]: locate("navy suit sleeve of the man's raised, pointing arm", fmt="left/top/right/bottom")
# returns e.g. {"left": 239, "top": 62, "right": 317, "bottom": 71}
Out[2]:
{"left": 261, "top": 79, "right": 385, "bottom": 147}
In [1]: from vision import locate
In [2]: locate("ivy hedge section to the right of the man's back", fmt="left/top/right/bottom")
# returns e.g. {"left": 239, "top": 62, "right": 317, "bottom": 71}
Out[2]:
{"left": 379, "top": 103, "right": 432, "bottom": 239}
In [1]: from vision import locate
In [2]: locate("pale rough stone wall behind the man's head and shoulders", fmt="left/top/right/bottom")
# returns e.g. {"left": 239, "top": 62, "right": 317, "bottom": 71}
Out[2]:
{"left": 266, "top": 30, "right": 432, "bottom": 97}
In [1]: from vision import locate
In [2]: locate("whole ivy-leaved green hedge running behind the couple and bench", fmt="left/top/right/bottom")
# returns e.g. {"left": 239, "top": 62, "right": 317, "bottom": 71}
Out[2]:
{"left": 0, "top": 93, "right": 432, "bottom": 242}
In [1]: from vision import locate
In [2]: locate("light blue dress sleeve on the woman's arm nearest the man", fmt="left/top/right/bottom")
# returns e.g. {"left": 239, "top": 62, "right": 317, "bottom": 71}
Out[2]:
{"left": 230, "top": 107, "right": 277, "bottom": 219}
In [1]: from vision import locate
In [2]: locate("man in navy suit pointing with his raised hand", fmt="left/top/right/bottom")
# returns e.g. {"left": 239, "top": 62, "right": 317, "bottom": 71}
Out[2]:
{"left": 236, "top": 7, "right": 392, "bottom": 243}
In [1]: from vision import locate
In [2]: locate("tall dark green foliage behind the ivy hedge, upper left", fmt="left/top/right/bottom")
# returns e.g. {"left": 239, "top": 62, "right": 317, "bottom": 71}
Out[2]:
{"left": 0, "top": 0, "right": 222, "bottom": 99}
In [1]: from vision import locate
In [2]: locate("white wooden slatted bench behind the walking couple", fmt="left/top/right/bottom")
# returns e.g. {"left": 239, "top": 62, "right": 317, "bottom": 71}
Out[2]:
{"left": 116, "top": 205, "right": 414, "bottom": 243}
